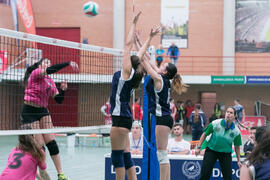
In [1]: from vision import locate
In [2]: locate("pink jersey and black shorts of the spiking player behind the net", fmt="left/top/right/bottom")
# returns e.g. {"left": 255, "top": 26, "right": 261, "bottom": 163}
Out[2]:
{"left": 21, "top": 68, "right": 58, "bottom": 124}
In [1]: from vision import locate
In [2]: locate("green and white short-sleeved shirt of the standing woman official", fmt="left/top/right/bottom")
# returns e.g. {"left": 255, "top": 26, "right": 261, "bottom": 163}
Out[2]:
{"left": 204, "top": 119, "right": 242, "bottom": 153}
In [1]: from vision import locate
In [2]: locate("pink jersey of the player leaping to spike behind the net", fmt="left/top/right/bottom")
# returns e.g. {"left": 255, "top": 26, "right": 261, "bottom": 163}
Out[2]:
{"left": 24, "top": 68, "right": 58, "bottom": 108}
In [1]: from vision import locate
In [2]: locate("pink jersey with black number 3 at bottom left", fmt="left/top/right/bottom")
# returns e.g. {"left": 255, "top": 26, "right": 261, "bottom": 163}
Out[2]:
{"left": 0, "top": 147, "right": 46, "bottom": 180}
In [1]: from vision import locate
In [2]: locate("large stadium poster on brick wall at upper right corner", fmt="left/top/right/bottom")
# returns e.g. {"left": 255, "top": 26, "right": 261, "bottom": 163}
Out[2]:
{"left": 235, "top": 0, "right": 270, "bottom": 53}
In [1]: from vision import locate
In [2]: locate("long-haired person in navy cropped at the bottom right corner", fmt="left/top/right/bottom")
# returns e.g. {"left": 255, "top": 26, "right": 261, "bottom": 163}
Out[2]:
{"left": 240, "top": 127, "right": 270, "bottom": 180}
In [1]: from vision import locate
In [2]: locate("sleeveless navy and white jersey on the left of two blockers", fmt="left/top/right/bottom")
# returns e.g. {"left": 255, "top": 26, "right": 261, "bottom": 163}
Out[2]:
{"left": 110, "top": 68, "right": 135, "bottom": 118}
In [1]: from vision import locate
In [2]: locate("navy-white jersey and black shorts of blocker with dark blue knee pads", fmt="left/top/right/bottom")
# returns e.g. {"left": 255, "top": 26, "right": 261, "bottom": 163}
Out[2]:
{"left": 110, "top": 69, "right": 135, "bottom": 130}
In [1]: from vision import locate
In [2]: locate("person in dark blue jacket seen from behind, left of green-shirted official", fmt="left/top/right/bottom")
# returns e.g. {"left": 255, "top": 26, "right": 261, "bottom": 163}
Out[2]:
{"left": 188, "top": 104, "right": 206, "bottom": 141}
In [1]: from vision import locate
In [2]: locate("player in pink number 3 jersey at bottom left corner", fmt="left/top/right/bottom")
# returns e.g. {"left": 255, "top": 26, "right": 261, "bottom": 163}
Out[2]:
{"left": 0, "top": 135, "right": 49, "bottom": 180}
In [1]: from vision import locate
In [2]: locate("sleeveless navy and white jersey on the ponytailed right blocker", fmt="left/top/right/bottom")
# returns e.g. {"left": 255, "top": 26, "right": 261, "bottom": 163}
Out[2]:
{"left": 146, "top": 75, "right": 171, "bottom": 117}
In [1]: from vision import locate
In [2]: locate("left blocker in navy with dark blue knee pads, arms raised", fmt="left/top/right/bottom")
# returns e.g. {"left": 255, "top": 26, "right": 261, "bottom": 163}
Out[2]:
{"left": 110, "top": 12, "right": 158, "bottom": 180}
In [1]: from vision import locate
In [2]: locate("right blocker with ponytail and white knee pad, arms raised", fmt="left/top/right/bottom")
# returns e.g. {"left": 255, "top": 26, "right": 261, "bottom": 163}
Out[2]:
{"left": 142, "top": 41, "right": 187, "bottom": 179}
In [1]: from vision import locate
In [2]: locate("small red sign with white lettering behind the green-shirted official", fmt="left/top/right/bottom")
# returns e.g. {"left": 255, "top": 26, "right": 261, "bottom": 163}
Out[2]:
{"left": 240, "top": 116, "right": 266, "bottom": 135}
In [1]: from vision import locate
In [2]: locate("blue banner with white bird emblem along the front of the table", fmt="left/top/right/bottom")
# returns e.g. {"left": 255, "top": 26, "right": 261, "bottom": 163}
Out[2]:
{"left": 105, "top": 155, "right": 240, "bottom": 180}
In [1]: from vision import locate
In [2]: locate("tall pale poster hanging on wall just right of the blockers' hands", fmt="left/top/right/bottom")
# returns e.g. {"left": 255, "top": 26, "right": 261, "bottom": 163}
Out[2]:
{"left": 161, "top": 0, "right": 189, "bottom": 48}
